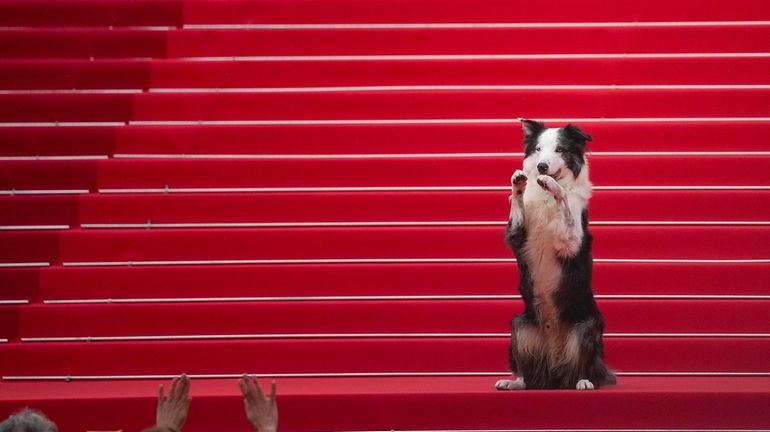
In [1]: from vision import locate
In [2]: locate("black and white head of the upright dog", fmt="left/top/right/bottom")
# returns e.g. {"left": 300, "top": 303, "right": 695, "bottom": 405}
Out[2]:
{"left": 519, "top": 119, "right": 591, "bottom": 181}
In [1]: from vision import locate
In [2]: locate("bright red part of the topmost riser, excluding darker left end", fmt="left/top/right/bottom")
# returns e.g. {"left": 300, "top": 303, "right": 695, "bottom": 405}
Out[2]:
{"left": 184, "top": 0, "right": 767, "bottom": 24}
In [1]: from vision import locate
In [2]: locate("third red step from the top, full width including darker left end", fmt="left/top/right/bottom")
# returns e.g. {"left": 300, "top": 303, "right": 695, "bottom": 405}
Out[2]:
{"left": 7, "top": 56, "right": 770, "bottom": 91}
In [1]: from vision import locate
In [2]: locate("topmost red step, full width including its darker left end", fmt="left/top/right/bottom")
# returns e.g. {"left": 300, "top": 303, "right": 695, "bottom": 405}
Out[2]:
{"left": 6, "top": 0, "right": 767, "bottom": 26}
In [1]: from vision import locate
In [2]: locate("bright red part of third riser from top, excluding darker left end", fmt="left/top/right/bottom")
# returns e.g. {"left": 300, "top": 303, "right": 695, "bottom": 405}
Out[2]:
{"left": 146, "top": 58, "right": 770, "bottom": 88}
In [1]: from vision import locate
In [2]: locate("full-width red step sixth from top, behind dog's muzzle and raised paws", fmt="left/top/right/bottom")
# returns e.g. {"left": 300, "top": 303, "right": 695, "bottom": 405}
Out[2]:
{"left": 0, "top": 155, "right": 770, "bottom": 192}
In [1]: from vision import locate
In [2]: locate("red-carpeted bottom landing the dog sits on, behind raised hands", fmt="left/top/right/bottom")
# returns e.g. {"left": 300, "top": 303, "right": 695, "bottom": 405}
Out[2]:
{"left": 0, "top": 376, "right": 770, "bottom": 430}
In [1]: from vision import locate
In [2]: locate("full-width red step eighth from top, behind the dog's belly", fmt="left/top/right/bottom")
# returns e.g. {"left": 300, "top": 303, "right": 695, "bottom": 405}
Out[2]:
{"left": 0, "top": 226, "right": 770, "bottom": 265}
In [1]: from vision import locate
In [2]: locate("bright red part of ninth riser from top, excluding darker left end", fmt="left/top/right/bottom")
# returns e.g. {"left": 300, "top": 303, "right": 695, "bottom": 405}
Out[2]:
{"left": 34, "top": 263, "right": 770, "bottom": 301}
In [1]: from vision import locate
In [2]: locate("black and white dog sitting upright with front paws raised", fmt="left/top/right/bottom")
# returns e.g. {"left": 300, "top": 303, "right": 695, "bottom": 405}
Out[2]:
{"left": 495, "top": 119, "right": 616, "bottom": 390}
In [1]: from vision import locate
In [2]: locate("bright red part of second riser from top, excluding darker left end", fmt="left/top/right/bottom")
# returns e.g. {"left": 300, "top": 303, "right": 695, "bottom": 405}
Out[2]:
{"left": 168, "top": 25, "right": 770, "bottom": 57}
